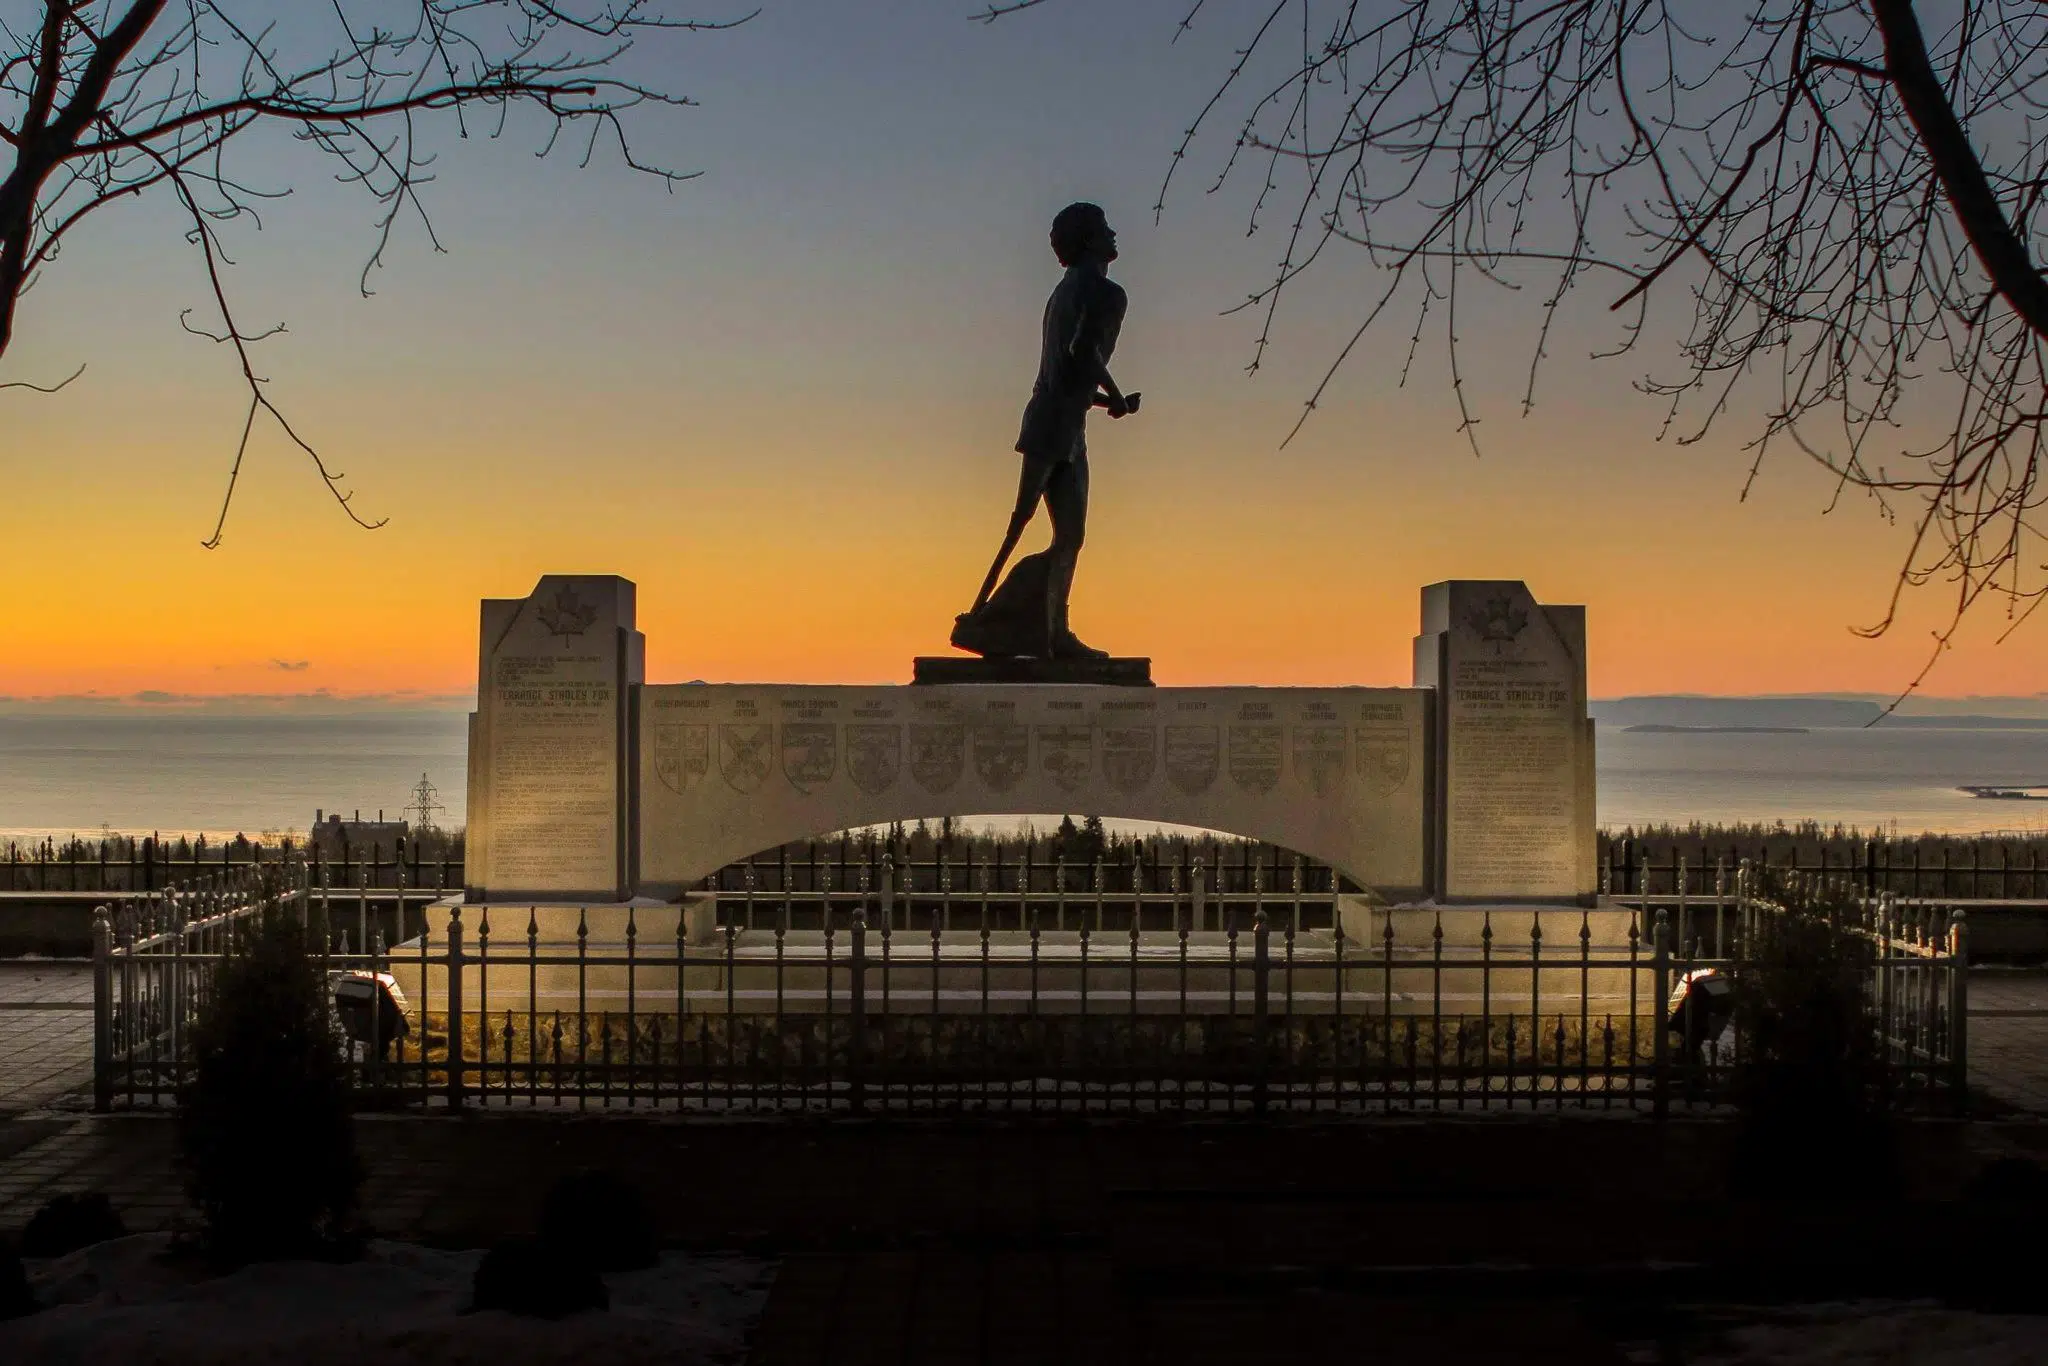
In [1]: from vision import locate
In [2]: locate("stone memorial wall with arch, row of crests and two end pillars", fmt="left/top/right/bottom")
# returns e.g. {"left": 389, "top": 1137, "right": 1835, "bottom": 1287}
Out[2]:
{"left": 467, "top": 575, "right": 1595, "bottom": 903}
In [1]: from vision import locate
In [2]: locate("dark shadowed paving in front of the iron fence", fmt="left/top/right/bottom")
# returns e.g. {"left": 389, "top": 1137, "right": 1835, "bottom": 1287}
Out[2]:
{"left": 0, "top": 1114, "right": 2048, "bottom": 1366}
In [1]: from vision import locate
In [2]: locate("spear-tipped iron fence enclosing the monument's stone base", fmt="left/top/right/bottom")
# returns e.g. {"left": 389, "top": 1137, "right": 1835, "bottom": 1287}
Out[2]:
{"left": 94, "top": 858, "right": 1968, "bottom": 1116}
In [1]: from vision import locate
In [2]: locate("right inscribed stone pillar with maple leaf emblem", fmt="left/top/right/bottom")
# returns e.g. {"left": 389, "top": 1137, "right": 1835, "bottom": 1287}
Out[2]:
{"left": 1415, "top": 580, "right": 1599, "bottom": 903}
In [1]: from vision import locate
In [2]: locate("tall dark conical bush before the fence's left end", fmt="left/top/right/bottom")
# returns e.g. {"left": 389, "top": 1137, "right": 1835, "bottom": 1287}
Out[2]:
{"left": 178, "top": 888, "right": 362, "bottom": 1262}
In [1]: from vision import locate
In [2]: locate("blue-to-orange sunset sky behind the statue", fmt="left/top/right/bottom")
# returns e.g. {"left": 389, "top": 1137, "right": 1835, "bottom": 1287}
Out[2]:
{"left": 0, "top": 0, "right": 2048, "bottom": 698}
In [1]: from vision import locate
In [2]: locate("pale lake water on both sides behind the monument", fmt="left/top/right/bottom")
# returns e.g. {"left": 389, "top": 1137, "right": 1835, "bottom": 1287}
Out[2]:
{"left": 0, "top": 711, "right": 2048, "bottom": 840}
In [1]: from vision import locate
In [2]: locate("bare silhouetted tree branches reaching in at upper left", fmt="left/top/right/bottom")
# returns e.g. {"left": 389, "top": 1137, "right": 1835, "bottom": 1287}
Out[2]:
{"left": 0, "top": 0, "right": 748, "bottom": 549}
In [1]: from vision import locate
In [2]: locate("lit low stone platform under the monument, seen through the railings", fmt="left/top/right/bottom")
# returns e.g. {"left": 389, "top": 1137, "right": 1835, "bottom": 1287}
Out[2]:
{"left": 391, "top": 893, "right": 1655, "bottom": 1020}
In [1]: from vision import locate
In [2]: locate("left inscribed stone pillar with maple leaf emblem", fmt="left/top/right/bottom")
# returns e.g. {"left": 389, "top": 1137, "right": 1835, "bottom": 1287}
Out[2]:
{"left": 463, "top": 573, "right": 645, "bottom": 901}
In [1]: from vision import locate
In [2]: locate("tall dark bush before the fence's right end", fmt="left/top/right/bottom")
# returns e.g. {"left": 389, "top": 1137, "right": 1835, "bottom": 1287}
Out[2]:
{"left": 1733, "top": 877, "right": 1892, "bottom": 1196}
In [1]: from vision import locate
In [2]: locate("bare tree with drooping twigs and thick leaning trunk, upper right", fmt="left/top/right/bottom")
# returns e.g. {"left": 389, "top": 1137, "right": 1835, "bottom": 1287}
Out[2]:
{"left": 979, "top": 0, "right": 2048, "bottom": 684}
